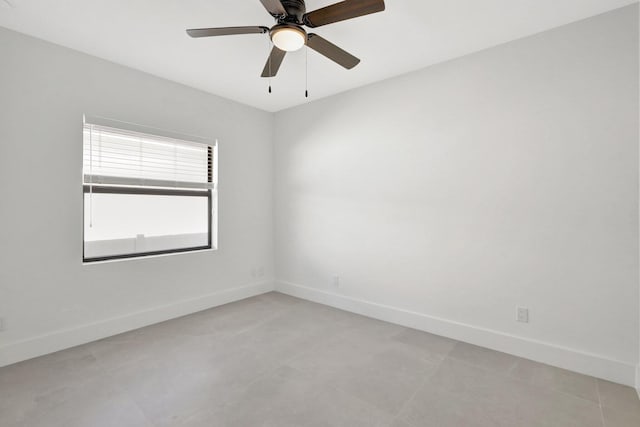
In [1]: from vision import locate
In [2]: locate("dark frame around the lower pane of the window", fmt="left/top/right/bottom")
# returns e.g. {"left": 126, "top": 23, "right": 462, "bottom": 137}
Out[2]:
{"left": 82, "top": 184, "right": 213, "bottom": 263}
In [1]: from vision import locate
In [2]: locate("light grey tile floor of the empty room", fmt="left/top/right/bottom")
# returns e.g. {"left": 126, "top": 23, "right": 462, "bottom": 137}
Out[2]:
{"left": 0, "top": 293, "right": 640, "bottom": 427}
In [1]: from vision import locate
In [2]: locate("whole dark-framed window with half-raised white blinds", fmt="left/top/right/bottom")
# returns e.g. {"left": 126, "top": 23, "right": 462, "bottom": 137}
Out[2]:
{"left": 83, "top": 118, "right": 217, "bottom": 262}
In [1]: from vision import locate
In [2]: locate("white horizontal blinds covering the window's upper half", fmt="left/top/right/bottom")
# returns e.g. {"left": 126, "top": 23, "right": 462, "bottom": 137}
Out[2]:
{"left": 83, "top": 122, "right": 214, "bottom": 189}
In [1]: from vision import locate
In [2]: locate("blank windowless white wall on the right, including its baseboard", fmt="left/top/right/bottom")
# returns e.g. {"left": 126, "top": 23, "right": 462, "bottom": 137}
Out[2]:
{"left": 274, "top": 5, "right": 639, "bottom": 384}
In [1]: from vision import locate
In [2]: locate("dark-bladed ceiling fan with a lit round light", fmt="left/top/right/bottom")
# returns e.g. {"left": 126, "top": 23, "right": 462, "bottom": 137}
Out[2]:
{"left": 187, "top": 0, "right": 385, "bottom": 77}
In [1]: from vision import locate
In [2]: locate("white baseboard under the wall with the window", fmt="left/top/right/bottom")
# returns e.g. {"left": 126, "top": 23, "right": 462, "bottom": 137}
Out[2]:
{"left": 0, "top": 282, "right": 274, "bottom": 367}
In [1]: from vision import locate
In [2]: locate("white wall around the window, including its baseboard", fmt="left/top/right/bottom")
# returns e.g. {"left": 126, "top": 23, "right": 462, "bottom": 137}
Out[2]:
{"left": 0, "top": 28, "right": 273, "bottom": 366}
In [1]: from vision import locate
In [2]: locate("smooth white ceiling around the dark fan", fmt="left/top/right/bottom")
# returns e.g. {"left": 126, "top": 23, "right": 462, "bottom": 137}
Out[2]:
{"left": 0, "top": 0, "right": 637, "bottom": 111}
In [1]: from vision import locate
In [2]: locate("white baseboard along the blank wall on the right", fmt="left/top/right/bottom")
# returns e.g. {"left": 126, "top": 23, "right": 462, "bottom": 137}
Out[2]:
{"left": 275, "top": 281, "right": 640, "bottom": 388}
